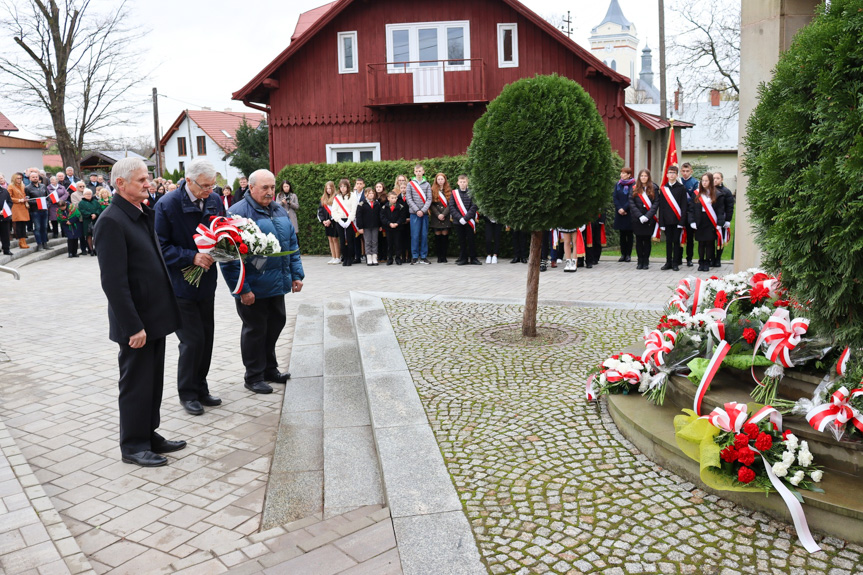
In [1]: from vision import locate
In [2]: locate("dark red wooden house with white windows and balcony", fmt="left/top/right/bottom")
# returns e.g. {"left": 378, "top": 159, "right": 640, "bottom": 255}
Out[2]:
{"left": 233, "top": 0, "right": 633, "bottom": 169}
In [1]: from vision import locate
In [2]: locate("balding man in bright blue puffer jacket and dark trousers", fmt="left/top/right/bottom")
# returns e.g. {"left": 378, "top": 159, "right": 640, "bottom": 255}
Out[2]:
{"left": 221, "top": 170, "right": 305, "bottom": 393}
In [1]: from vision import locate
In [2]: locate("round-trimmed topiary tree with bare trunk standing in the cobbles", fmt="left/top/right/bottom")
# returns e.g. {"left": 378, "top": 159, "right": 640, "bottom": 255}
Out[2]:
{"left": 468, "top": 75, "right": 616, "bottom": 337}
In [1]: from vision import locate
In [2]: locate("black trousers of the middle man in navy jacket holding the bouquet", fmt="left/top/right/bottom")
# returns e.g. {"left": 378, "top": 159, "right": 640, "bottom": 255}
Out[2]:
{"left": 176, "top": 297, "right": 215, "bottom": 401}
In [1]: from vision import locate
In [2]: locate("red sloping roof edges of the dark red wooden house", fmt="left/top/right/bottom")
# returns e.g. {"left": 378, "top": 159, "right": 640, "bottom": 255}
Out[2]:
{"left": 231, "top": 0, "right": 630, "bottom": 102}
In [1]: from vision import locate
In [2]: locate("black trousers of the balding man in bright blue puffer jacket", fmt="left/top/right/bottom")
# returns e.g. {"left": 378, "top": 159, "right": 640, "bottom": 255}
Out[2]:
{"left": 234, "top": 294, "right": 286, "bottom": 383}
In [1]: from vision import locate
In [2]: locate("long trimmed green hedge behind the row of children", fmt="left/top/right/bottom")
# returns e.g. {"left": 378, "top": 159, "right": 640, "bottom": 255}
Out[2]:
{"left": 276, "top": 156, "right": 617, "bottom": 258}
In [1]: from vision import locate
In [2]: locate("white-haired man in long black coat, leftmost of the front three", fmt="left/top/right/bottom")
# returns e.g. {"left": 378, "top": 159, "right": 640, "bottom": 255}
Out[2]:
{"left": 94, "top": 158, "right": 186, "bottom": 467}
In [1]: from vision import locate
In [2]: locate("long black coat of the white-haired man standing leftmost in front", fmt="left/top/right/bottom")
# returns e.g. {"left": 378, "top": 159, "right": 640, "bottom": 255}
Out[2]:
{"left": 94, "top": 194, "right": 180, "bottom": 344}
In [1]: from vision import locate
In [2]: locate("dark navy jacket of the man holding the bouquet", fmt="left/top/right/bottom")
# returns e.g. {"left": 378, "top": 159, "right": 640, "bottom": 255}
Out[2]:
{"left": 155, "top": 183, "right": 224, "bottom": 301}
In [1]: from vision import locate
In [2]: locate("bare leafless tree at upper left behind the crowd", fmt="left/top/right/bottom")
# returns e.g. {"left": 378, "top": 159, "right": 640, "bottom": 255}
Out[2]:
{"left": 0, "top": 0, "right": 146, "bottom": 169}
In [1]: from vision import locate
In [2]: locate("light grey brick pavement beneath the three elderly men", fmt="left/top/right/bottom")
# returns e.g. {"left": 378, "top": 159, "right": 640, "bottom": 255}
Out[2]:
{"left": 0, "top": 256, "right": 729, "bottom": 573}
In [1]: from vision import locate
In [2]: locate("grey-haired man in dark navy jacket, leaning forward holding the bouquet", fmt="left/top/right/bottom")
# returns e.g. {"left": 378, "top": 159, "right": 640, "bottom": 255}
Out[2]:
{"left": 155, "top": 159, "right": 223, "bottom": 415}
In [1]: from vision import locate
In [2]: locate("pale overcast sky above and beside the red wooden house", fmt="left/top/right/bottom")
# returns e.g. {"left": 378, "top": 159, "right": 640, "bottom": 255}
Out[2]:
{"left": 0, "top": 0, "right": 673, "bottom": 143}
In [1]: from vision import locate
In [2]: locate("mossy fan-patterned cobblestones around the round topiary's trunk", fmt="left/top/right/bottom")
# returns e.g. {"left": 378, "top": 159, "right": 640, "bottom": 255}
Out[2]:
{"left": 385, "top": 299, "right": 863, "bottom": 575}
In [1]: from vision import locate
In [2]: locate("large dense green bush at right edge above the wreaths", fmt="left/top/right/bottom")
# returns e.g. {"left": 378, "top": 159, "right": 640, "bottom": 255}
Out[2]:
{"left": 744, "top": 0, "right": 863, "bottom": 347}
